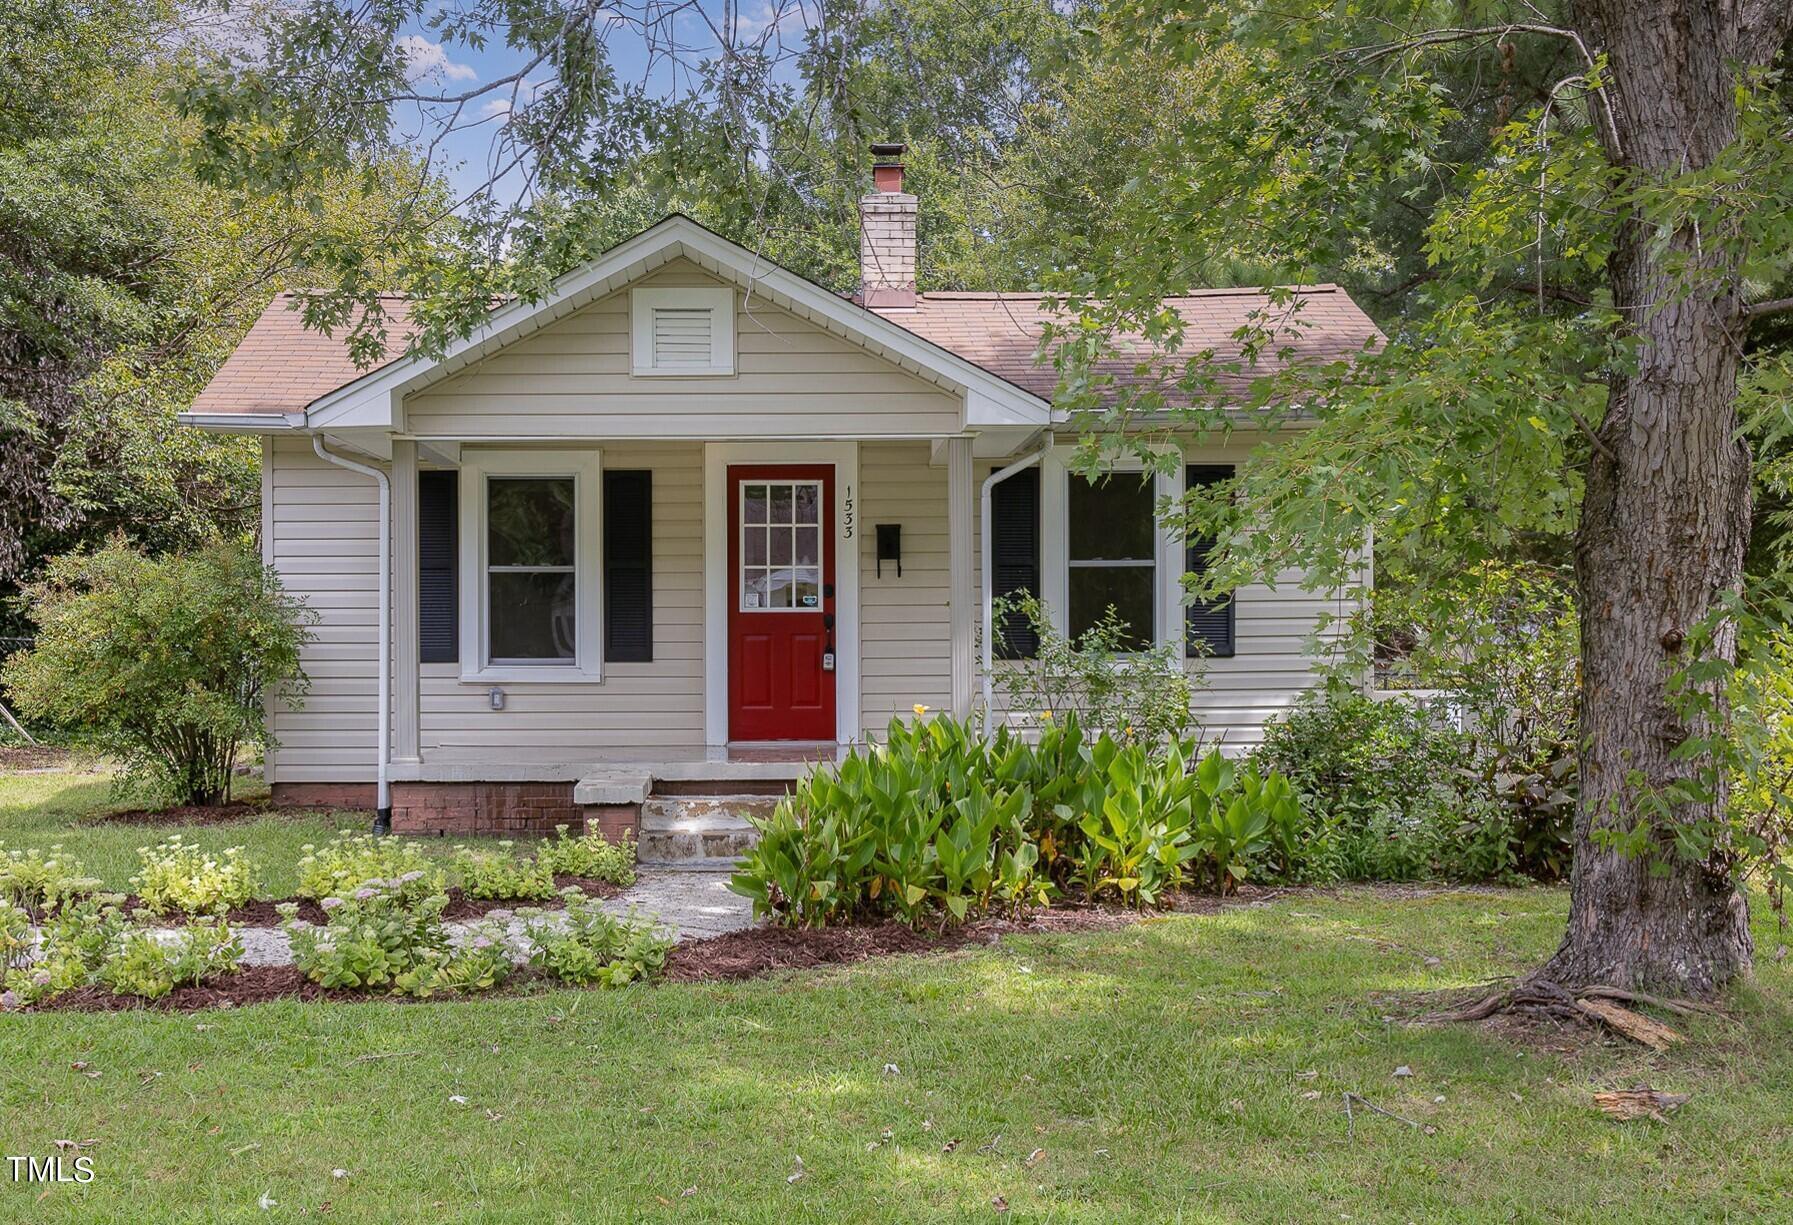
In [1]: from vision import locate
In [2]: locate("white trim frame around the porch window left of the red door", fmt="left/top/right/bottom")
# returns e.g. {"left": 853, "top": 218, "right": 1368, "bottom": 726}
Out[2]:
{"left": 459, "top": 448, "right": 604, "bottom": 685}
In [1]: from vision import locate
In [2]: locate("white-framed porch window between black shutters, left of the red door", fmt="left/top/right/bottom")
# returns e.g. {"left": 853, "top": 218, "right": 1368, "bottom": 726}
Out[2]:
{"left": 461, "top": 448, "right": 602, "bottom": 682}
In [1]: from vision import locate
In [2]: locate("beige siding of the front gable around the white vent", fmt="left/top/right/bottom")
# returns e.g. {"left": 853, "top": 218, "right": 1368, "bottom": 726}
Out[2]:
{"left": 405, "top": 260, "right": 961, "bottom": 439}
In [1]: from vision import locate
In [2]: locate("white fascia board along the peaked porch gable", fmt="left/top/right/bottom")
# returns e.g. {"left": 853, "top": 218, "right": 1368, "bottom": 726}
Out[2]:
{"left": 294, "top": 215, "right": 1051, "bottom": 429}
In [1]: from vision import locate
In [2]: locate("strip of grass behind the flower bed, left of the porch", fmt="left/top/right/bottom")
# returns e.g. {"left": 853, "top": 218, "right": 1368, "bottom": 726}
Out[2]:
{"left": 0, "top": 769, "right": 498, "bottom": 896}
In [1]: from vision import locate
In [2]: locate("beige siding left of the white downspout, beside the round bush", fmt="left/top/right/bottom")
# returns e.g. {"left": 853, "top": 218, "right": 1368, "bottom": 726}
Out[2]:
{"left": 262, "top": 439, "right": 380, "bottom": 782}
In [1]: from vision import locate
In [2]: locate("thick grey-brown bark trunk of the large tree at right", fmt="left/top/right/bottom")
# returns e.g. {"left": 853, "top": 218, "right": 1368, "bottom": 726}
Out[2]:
{"left": 1544, "top": 0, "right": 1786, "bottom": 995}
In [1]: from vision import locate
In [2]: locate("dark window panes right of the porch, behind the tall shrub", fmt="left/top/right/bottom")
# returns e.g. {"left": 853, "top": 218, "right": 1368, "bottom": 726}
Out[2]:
{"left": 1065, "top": 472, "right": 1158, "bottom": 649}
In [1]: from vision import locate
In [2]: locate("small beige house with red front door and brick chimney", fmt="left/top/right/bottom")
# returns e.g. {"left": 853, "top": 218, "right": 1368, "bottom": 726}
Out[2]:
{"left": 181, "top": 147, "right": 1375, "bottom": 832}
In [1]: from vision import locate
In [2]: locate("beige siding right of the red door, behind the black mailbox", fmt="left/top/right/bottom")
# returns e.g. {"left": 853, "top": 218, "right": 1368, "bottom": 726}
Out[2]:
{"left": 859, "top": 443, "right": 952, "bottom": 735}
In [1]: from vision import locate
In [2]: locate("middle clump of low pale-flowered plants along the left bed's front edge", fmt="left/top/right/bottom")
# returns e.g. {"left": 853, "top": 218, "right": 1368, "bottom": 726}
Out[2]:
{"left": 280, "top": 882, "right": 448, "bottom": 990}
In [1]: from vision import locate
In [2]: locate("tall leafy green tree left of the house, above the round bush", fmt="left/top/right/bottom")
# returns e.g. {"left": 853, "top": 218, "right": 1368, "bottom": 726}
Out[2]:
{"left": 0, "top": 0, "right": 430, "bottom": 633}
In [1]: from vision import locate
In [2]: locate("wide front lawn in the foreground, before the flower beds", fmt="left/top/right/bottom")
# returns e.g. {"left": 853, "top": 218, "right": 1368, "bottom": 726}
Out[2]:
{"left": 0, "top": 771, "right": 1793, "bottom": 1225}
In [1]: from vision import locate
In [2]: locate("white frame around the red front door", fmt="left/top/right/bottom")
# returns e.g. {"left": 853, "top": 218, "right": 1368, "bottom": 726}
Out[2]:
{"left": 703, "top": 441, "right": 861, "bottom": 746}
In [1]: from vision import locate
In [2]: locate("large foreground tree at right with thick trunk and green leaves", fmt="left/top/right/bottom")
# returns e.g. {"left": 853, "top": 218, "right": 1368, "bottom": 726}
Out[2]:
{"left": 1052, "top": 0, "right": 1793, "bottom": 994}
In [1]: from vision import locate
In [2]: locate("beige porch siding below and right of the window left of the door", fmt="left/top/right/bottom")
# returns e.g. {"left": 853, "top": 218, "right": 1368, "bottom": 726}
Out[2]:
{"left": 418, "top": 443, "right": 703, "bottom": 766}
